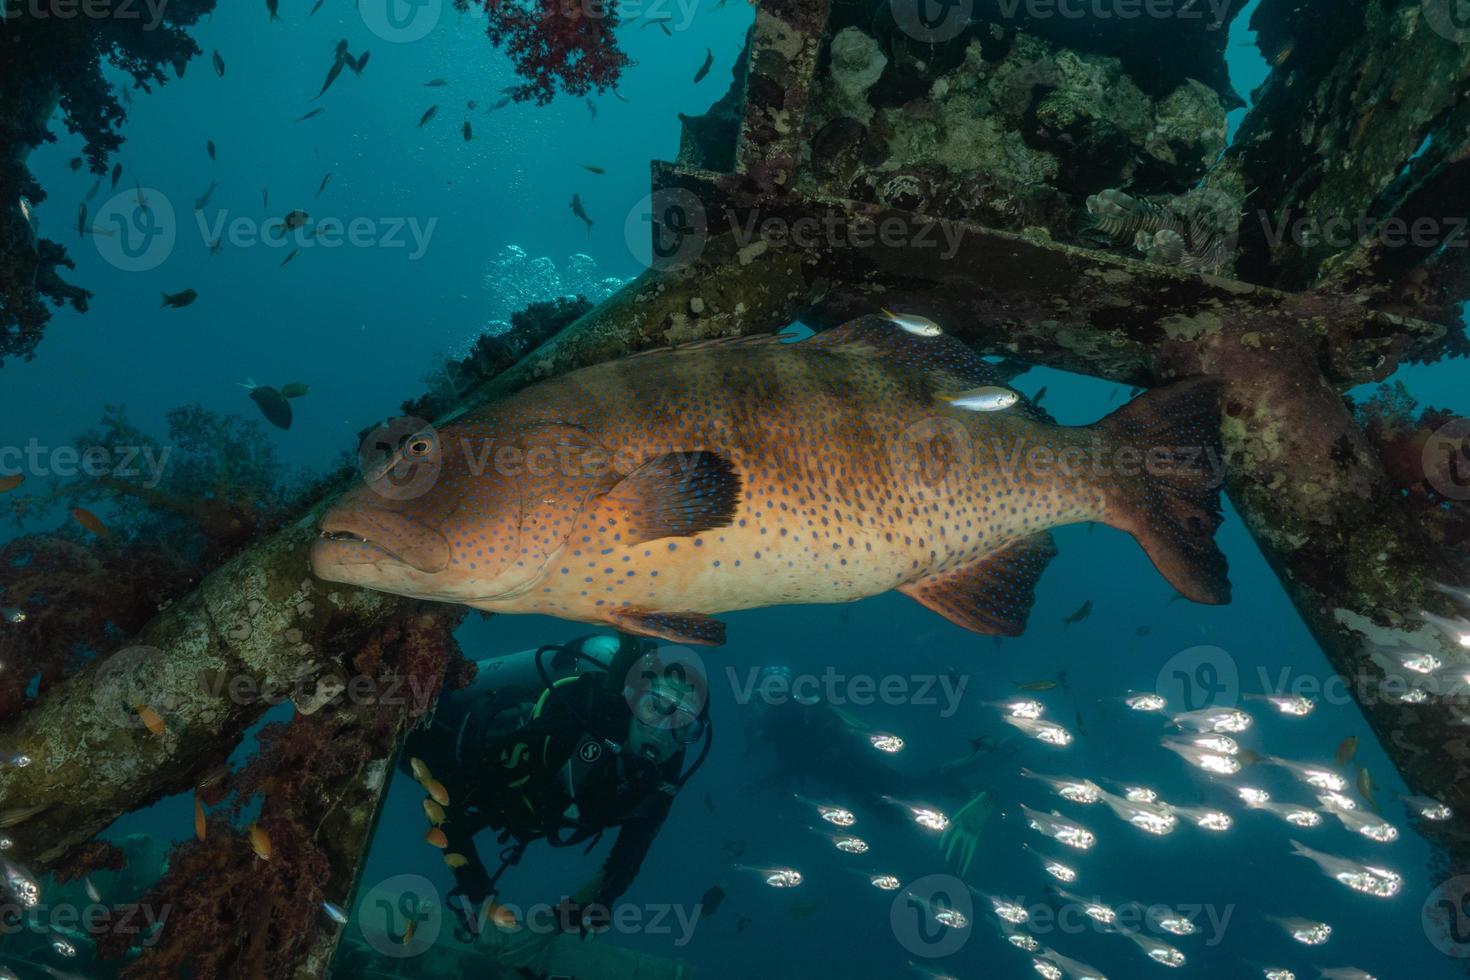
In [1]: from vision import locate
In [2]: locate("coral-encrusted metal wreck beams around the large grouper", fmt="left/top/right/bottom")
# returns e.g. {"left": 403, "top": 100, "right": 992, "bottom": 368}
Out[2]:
{"left": 0, "top": 0, "right": 1470, "bottom": 977}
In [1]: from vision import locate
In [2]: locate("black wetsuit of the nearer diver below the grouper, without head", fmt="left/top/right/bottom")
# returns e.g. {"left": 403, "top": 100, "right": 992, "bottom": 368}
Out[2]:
{"left": 403, "top": 645, "right": 685, "bottom": 907}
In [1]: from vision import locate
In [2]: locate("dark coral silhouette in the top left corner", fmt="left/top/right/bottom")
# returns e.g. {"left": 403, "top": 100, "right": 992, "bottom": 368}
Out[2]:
{"left": 0, "top": 0, "right": 215, "bottom": 363}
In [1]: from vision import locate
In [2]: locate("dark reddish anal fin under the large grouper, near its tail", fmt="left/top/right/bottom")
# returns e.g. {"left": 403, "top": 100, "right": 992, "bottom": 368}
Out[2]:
{"left": 898, "top": 530, "right": 1057, "bottom": 636}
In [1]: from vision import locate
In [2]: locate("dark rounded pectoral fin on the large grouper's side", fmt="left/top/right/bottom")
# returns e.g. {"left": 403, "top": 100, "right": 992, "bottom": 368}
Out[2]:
{"left": 591, "top": 451, "right": 741, "bottom": 545}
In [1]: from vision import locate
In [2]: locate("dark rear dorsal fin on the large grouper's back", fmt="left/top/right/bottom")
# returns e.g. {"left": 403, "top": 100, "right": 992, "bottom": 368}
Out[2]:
{"left": 801, "top": 316, "right": 1050, "bottom": 422}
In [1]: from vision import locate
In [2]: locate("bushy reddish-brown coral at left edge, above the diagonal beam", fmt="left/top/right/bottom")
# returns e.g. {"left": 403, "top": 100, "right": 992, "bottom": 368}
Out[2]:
{"left": 0, "top": 406, "right": 316, "bottom": 718}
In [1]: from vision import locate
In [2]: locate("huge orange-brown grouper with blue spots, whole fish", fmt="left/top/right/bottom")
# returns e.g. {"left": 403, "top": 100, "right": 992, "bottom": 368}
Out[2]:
{"left": 312, "top": 316, "right": 1230, "bottom": 645}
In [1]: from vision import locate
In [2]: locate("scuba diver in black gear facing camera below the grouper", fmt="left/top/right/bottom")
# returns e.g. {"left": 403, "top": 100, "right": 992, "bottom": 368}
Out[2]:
{"left": 401, "top": 635, "right": 711, "bottom": 939}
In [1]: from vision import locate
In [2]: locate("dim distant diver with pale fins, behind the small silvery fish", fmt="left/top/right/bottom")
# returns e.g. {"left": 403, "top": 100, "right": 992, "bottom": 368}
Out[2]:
{"left": 750, "top": 667, "right": 998, "bottom": 877}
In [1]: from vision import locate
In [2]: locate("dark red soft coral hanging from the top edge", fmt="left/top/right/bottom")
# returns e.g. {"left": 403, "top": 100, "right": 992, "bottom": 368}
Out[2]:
{"left": 454, "top": 0, "right": 631, "bottom": 106}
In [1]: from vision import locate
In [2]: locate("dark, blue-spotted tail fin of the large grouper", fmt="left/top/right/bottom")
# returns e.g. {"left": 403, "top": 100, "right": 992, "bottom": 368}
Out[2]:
{"left": 1095, "top": 376, "right": 1230, "bottom": 605}
